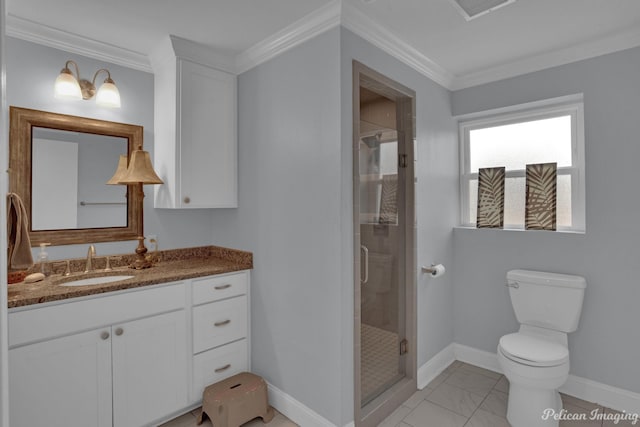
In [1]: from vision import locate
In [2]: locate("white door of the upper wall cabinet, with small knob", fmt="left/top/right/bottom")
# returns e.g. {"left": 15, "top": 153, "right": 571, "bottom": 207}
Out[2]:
{"left": 178, "top": 60, "right": 238, "bottom": 208}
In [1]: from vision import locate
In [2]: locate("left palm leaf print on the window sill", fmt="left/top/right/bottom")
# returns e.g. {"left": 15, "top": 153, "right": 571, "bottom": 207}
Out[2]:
{"left": 476, "top": 167, "right": 505, "bottom": 228}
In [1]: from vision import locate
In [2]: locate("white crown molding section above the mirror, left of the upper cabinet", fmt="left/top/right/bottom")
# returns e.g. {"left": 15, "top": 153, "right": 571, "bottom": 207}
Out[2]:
{"left": 6, "top": 14, "right": 153, "bottom": 73}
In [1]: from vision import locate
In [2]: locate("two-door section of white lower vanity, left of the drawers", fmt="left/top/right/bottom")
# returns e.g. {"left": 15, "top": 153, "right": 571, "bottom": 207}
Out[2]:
{"left": 9, "top": 283, "right": 188, "bottom": 427}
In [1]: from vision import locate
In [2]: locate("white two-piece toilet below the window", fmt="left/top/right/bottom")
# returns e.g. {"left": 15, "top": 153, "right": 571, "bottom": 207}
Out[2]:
{"left": 498, "top": 270, "right": 587, "bottom": 427}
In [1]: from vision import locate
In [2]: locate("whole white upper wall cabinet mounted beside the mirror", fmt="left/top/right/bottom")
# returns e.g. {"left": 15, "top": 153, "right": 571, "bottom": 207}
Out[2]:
{"left": 151, "top": 36, "right": 238, "bottom": 208}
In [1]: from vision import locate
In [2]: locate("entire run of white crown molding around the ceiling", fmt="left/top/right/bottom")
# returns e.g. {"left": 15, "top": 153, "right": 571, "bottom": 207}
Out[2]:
{"left": 6, "top": 4, "right": 640, "bottom": 91}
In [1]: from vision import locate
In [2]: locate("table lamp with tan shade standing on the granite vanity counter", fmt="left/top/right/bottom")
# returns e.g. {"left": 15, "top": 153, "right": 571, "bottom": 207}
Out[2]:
{"left": 107, "top": 147, "right": 164, "bottom": 270}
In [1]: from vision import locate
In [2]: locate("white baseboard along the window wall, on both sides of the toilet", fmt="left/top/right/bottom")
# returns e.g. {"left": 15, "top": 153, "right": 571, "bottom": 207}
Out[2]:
{"left": 450, "top": 344, "right": 640, "bottom": 414}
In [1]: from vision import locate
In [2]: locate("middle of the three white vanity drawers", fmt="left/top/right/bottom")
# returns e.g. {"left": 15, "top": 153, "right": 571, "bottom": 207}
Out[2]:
{"left": 193, "top": 295, "right": 247, "bottom": 353}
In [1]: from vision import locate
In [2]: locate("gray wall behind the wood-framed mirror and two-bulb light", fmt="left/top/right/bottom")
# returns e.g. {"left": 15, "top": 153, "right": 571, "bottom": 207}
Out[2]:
{"left": 7, "top": 37, "right": 212, "bottom": 259}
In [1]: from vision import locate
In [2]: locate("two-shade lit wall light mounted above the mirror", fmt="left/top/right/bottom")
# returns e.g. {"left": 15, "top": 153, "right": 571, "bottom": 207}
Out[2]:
{"left": 54, "top": 60, "right": 120, "bottom": 108}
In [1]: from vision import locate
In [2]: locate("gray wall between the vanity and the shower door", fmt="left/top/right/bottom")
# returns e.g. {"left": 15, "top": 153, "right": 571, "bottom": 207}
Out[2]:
{"left": 212, "top": 29, "right": 344, "bottom": 424}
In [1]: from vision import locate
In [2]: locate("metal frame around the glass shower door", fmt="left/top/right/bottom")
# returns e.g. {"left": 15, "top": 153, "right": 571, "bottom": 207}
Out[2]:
{"left": 352, "top": 60, "right": 417, "bottom": 427}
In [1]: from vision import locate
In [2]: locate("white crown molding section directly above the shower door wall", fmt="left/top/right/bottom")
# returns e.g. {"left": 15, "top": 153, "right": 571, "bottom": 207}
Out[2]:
{"left": 341, "top": 3, "right": 455, "bottom": 89}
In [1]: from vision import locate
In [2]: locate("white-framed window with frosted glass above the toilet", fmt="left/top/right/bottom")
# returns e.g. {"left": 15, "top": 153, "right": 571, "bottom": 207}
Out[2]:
{"left": 459, "top": 95, "right": 585, "bottom": 231}
